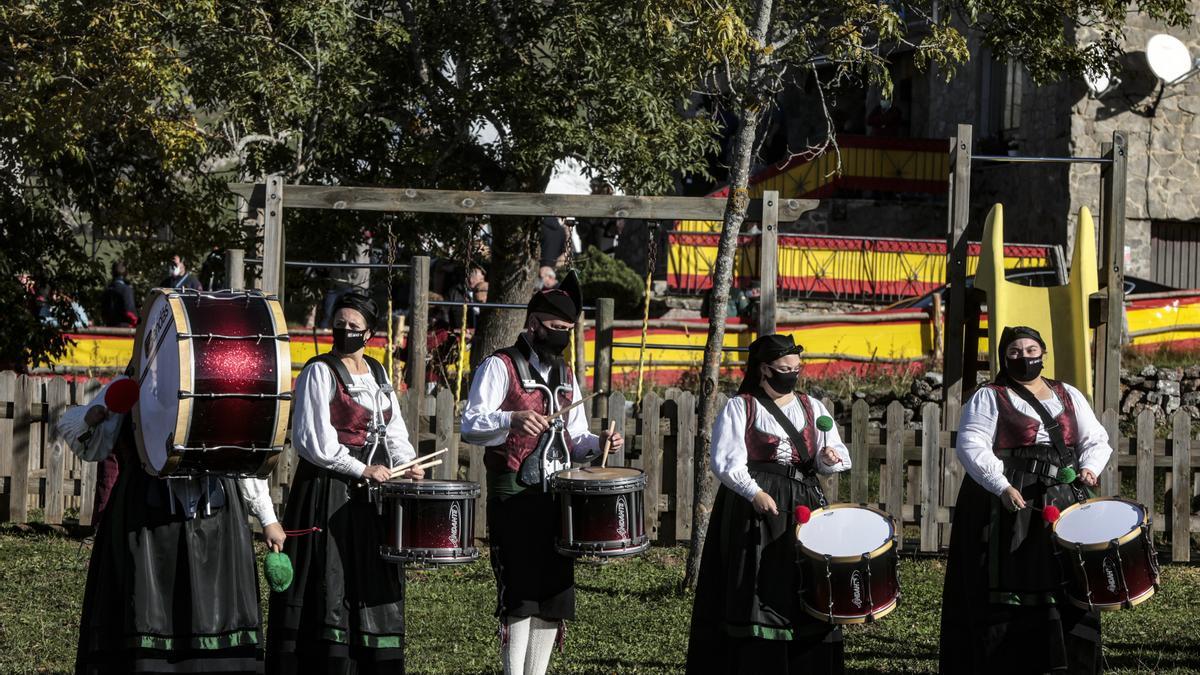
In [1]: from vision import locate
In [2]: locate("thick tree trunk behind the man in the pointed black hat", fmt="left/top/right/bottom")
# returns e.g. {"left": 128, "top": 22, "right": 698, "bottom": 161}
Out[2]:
{"left": 470, "top": 216, "right": 540, "bottom": 371}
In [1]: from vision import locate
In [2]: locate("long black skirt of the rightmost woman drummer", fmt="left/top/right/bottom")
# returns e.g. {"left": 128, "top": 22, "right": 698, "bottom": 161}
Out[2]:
{"left": 941, "top": 450, "right": 1103, "bottom": 674}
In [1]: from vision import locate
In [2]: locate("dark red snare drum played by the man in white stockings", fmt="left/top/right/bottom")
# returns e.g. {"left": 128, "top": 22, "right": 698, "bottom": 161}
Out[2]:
{"left": 550, "top": 466, "right": 650, "bottom": 557}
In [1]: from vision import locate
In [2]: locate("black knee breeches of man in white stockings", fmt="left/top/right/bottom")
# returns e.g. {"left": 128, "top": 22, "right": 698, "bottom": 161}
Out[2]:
{"left": 487, "top": 473, "right": 575, "bottom": 621}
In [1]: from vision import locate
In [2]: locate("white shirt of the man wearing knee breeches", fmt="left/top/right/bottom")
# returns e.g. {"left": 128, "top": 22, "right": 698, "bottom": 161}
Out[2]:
{"left": 461, "top": 345, "right": 600, "bottom": 459}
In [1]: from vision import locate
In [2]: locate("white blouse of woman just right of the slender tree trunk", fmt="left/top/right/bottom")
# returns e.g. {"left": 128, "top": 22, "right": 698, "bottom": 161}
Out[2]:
{"left": 712, "top": 396, "right": 850, "bottom": 500}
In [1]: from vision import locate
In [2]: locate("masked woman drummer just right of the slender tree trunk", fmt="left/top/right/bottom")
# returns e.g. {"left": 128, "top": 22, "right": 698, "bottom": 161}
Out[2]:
{"left": 688, "top": 335, "right": 850, "bottom": 675}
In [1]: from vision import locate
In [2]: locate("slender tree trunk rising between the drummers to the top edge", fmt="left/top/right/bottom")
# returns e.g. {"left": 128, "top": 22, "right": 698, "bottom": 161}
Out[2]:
{"left": 683, "top": 0, "right": 772, "bottom": 591}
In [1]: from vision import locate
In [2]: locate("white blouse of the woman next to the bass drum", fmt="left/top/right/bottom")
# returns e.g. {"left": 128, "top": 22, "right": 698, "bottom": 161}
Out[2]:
{"left": 292, "top": 362, "right": 416, "bottom": 478}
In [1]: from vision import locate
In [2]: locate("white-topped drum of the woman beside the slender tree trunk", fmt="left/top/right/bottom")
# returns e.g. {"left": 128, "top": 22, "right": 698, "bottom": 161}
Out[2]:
{"left": 796, "top": 504, "right": 900, "bottom": 623}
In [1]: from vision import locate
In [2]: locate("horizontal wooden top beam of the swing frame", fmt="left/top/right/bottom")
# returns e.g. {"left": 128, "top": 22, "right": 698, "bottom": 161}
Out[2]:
{"left": 229, "top": 183, "right": 820, "bottom": 222}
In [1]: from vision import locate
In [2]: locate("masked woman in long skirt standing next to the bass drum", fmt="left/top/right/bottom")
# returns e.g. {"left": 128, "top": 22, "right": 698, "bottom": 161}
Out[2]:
{"left": 266, "top": 292, "right": 425, "bottom": 675}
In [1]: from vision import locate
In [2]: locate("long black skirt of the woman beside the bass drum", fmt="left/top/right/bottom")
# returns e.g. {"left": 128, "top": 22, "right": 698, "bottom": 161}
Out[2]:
{"left": 266, "top": 454, "right": 404, "bottom": 674}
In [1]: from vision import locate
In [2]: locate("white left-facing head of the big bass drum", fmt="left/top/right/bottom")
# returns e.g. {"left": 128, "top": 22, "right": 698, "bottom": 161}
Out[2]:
{"left": 133, "top": 288, "right": 192, "bottom": 476}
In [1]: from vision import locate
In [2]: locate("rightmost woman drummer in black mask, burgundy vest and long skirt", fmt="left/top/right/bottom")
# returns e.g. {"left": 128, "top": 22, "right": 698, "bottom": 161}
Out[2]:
{"left": 941, "top": 325, "right": 1111, "bottom": 673}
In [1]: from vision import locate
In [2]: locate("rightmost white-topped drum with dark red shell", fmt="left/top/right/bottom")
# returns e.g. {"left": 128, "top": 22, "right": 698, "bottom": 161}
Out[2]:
{"left": 1054, "top": 497, "right": 1158, "bottom": 610}
